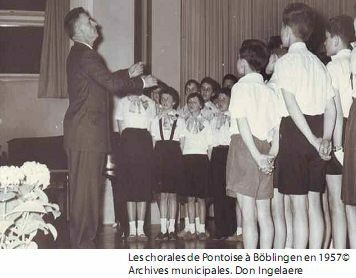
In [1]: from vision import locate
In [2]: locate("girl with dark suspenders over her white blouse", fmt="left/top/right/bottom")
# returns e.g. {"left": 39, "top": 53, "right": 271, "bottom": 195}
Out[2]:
{"left": 151, "top": 87, "right": 184, "bottom": 240}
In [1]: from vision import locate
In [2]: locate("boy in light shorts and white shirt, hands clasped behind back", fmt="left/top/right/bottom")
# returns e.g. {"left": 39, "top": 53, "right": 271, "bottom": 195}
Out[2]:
{"left": 226, "top": 40, "right": 280, "bottom": 248}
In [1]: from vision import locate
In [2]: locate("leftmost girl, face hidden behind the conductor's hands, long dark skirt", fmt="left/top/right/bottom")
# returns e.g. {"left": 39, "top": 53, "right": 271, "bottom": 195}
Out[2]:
{"left": 114, "top": 92, "right": 156, "bottom": 241}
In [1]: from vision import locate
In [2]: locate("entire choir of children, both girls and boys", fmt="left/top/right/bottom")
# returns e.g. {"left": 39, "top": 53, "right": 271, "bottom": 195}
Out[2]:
{"left": 114, "top": 3, "right": 356, "bottom": 248}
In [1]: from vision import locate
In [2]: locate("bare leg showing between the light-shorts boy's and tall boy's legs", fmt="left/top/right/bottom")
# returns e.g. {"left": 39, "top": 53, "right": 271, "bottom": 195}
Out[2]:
{"left": 272, "top": 188, "right": 287, "bottom": 249}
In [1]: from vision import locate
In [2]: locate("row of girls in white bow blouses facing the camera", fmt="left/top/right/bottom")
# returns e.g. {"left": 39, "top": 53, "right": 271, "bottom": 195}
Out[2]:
{"left": 113, "top": 75, "right": 242, "bottom": 241}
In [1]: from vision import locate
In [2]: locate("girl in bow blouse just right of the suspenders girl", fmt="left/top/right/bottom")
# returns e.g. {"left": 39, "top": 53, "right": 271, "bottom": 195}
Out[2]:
{"left": 182, "top": 93, "right": 212, "bottom": 239}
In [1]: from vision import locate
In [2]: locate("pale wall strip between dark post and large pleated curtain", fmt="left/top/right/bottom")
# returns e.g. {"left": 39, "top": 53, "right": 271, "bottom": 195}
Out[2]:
{"left": 152, "top": 0, "right": 181, "bottom": 91}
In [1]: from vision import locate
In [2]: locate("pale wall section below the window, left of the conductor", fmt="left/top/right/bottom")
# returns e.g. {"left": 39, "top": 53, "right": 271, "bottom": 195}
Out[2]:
{"left": 0, "top": 81, "right": 68, "bottom": 150}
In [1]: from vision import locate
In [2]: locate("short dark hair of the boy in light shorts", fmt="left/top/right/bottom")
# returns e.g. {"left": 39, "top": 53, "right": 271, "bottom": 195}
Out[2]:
{"left": 239, "top": 39, "right": 270, "bottom": 72}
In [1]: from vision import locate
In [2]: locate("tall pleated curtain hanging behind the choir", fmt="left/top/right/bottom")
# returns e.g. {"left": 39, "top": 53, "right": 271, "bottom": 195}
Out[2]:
{"left": 181, "top": 0, "right": 356, "bottom": 97}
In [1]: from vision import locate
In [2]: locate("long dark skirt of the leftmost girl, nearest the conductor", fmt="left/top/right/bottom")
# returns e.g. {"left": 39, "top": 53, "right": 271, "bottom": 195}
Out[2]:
{"left": 118, "top": 128, "right": 153, "bottom": 202}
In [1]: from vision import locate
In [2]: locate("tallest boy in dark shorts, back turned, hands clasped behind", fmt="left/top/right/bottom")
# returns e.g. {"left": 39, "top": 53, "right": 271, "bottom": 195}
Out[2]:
{"left": 272, "top": 3, "right": 336, "bottom": 248}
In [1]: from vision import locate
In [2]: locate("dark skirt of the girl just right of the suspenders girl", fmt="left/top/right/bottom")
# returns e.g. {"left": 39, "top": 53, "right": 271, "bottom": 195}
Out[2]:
{"left": 181, "top": 154, "right": 209, "bottom": 199}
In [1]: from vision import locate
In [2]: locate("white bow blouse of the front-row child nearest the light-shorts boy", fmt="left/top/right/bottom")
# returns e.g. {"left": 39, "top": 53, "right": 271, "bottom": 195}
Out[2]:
{"left": 211, "top": 111, "right": 238, "bottom": 147}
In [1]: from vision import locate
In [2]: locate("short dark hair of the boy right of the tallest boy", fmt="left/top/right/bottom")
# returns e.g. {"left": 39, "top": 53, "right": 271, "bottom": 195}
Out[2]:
{"left": 326, "top": 15, "right": 355, "bottom": 46}
